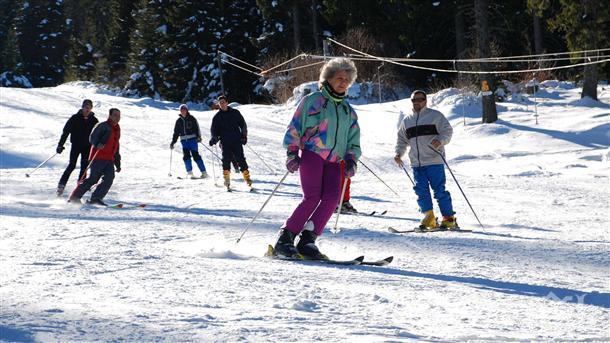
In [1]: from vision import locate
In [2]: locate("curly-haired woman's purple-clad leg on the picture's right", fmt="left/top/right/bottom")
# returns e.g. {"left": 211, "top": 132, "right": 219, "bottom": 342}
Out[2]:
{"left": 311, "top": 162, "right": 342, "bottom": 236}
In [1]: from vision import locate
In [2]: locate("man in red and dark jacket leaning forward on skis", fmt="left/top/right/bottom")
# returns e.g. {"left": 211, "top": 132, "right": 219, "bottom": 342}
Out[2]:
{"left": 68, "top": 108, "right": 121, "bottom": 206}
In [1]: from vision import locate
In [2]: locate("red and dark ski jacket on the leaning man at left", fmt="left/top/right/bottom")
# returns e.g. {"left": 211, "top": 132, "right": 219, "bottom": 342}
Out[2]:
{"left": 89, "top": 120, "right": 121, "bottom": 168}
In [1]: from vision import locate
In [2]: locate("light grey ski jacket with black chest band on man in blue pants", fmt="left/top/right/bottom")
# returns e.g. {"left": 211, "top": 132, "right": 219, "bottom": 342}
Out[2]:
{"left": 396, "top": 107, "right": 453, "bottom": 167}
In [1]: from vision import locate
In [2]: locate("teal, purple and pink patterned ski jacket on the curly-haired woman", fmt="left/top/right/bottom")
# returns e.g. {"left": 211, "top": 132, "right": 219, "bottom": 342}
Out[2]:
{"left": 284, "top": 88, "right": 362, "bottom": 162}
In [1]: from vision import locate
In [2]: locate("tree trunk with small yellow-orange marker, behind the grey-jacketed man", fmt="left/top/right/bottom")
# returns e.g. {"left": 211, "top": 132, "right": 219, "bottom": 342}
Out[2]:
{"left": 474, "top": 0, "right": 498, "bottom": 123}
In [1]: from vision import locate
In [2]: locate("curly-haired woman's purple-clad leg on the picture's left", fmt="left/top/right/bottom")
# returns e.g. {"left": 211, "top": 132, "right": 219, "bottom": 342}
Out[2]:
{"left": 284, "top": 150, "right": 326, "bottom": 234}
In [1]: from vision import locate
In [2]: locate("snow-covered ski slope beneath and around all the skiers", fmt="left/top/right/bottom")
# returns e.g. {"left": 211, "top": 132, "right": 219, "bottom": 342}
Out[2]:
{"left": 0, "top": 82, "right": 610, "bottom": 342}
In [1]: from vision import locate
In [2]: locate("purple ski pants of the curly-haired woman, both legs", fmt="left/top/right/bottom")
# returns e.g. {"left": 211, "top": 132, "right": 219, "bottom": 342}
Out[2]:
{"left": 285, "top": 150, "right": 341, "bottom": 236}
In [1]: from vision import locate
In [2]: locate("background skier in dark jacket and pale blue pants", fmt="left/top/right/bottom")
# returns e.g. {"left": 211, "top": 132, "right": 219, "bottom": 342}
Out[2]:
{"left": 169, "top": 104, "right": 208, "bottom": 179}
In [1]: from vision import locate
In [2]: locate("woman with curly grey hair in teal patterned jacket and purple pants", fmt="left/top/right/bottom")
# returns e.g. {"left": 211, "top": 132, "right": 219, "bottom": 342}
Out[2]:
{"left": 274, "top": 58, "right": 361, "bottom": 259}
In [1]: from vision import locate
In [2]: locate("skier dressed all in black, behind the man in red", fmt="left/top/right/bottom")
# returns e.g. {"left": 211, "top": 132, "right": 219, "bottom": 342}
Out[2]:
{"left": 55, "top": 99, "right": 98, "bottom": 196}
